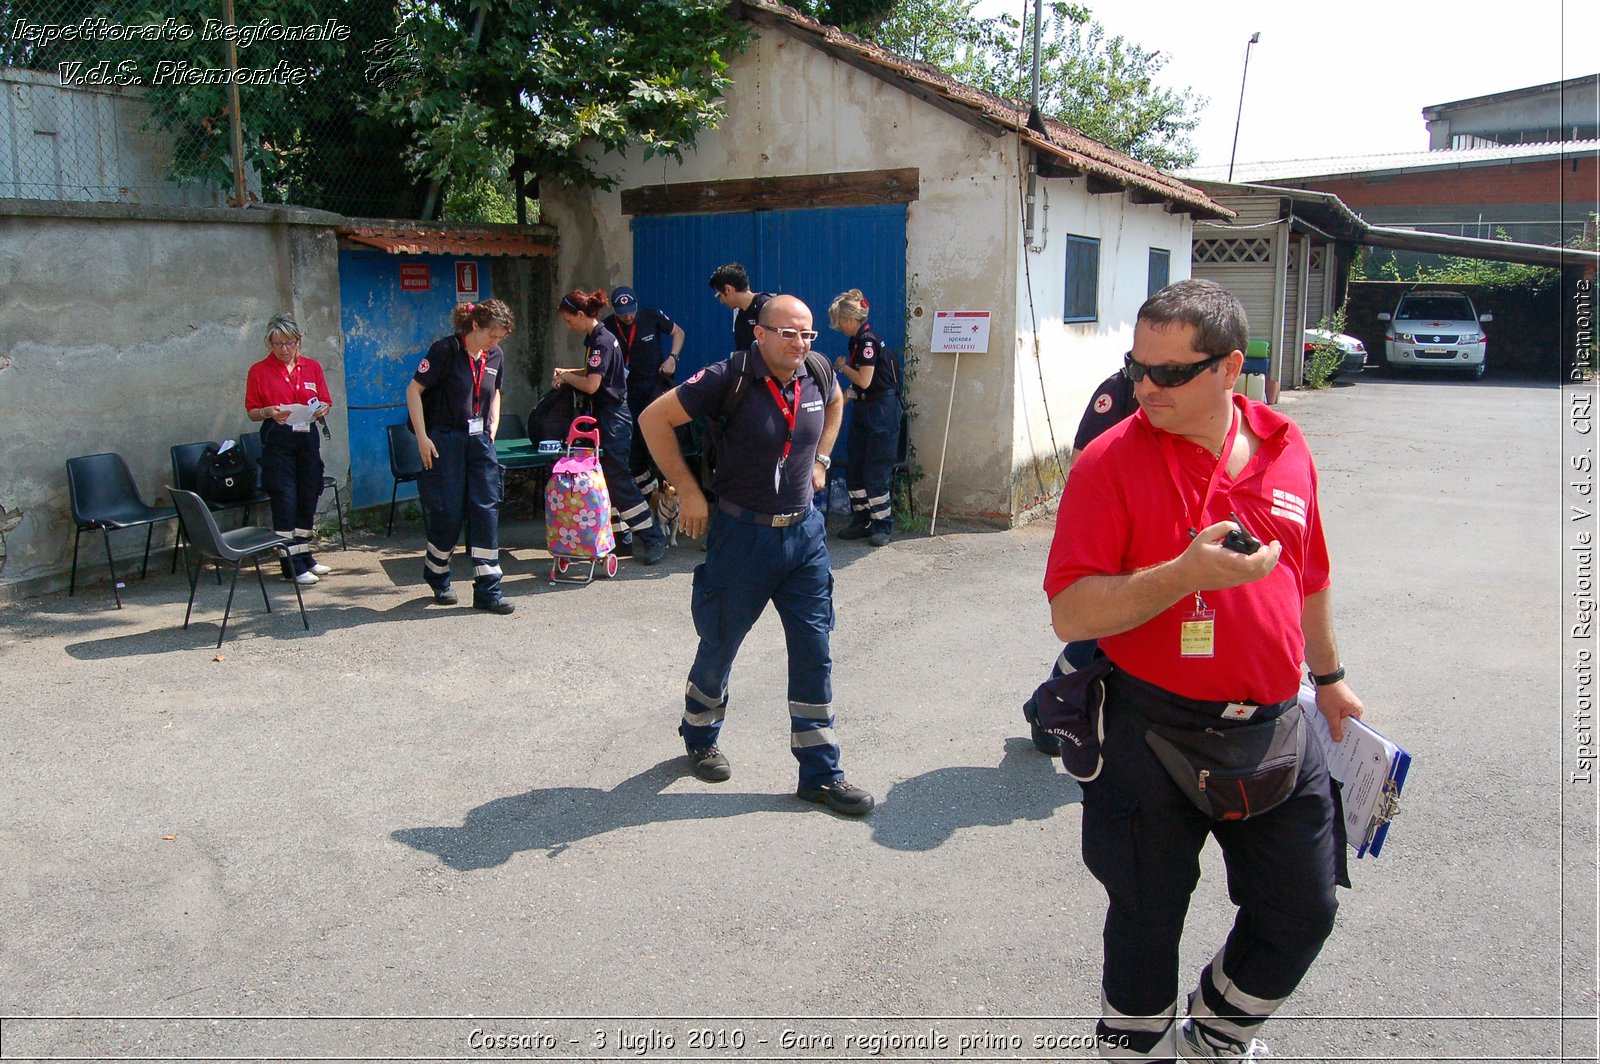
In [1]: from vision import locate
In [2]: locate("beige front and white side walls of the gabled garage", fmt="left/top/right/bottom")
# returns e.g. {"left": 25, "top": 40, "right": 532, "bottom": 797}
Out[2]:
{"left": 541, "top": 32, "right": 1189, "bottom": 522}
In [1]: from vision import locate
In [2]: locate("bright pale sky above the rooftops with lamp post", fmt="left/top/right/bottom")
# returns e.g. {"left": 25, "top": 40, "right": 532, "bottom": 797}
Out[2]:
{"left": 979, "top": 0, "right": 1600, "bottom": 165}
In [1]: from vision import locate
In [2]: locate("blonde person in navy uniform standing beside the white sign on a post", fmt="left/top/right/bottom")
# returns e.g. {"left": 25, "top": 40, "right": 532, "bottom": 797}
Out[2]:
{"left": 827, "top": 288, "right": 901, "bottom": 547}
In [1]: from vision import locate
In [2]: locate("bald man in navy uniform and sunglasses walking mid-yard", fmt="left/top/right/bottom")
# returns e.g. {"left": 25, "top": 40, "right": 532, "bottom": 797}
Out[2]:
{"left": 640, "top": 296, "right": 874, "bottom": 816}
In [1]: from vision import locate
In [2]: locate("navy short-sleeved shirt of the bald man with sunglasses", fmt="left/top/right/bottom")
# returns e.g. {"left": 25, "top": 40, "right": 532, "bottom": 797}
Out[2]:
{"left": 678, "top": 350, "right": 838, "bottom": 514}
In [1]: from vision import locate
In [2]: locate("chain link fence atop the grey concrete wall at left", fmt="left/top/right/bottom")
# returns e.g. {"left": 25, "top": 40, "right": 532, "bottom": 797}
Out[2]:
{"left": 0, "top": 0, "right": 486, "bottom": 221}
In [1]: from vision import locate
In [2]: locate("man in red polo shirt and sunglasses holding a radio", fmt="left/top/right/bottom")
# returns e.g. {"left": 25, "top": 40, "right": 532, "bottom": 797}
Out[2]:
{"left": 1045, "top": 280, "right": 1362, "bottom": 1061}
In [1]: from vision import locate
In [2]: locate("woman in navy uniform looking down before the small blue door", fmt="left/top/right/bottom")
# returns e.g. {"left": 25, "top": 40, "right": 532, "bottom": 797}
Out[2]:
{"left": 405, "top": 299, "right": 514, "bottom": 614}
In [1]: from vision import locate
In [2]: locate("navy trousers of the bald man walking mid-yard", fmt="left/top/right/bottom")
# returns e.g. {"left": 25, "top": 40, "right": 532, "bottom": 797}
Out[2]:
{"left": 678, "top": 509, "right": 843, "bottom": 787}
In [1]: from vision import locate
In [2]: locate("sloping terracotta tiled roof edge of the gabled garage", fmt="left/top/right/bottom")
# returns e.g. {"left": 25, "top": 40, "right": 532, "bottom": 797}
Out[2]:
{"left": 741, "top": 0, "right": 1232, "bottom": 218}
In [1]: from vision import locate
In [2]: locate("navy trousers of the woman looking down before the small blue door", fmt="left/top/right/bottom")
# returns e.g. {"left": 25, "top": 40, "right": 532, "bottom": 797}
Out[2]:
{"left": 416, "top": 429, "right": 506, "bottom": 602}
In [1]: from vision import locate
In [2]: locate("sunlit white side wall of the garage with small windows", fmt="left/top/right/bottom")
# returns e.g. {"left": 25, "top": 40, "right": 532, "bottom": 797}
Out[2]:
{"left": 1013, "top": 178, "right": 1192, "bottom": 510}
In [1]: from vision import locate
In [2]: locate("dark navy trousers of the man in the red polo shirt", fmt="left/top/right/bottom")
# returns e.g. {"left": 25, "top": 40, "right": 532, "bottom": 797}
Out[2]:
{"left": 1083, "top": 672, "right": 1349, "bottom": 1059}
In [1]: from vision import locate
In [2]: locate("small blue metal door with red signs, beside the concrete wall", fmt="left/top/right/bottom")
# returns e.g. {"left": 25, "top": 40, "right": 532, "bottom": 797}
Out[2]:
{"left": 339, "top": 251, "right": 493, "bottom": 507}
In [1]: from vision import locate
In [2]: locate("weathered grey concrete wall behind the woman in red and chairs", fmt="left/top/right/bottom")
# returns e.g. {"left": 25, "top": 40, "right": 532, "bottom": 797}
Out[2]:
{"left": 0, "top": 200, "right": 349, "bottom": 600}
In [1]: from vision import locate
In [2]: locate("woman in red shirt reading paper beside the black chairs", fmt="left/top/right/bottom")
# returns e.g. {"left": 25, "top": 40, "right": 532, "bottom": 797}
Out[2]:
{"left": 245, "top": 314, "right": 333, "bottom": 584}
